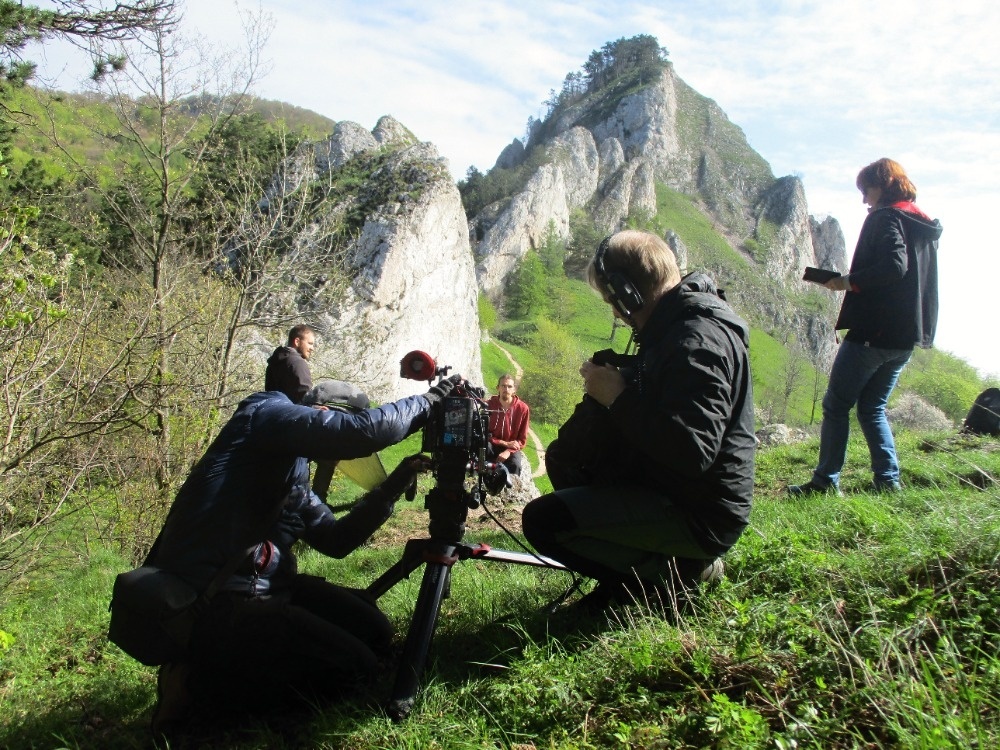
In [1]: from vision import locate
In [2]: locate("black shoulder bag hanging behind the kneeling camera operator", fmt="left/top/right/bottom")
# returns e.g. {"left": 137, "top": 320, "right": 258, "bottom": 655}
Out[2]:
{"left": 108, "top": 565, "right": 207, "bottom": 667}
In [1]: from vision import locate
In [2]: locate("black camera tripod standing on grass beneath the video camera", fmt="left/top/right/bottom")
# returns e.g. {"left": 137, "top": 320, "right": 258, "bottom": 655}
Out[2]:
{"left": 366, "top": 460, "right": 566, "bottom": 722}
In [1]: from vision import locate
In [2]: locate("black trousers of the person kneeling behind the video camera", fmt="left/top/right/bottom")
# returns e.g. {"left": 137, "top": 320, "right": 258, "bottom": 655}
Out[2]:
{"left": 190, "top": 575, "right": 393, "bottom": 710}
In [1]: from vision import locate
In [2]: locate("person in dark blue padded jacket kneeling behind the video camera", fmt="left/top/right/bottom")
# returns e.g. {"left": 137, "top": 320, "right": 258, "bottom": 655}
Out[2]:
{"left": 147, "top": 375, "right": 461, "bottom": 733}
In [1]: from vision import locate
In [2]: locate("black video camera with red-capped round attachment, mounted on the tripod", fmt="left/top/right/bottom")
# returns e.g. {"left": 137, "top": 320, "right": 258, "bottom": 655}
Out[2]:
{"left": 399, "top": 351, "right": 511, "bottom": 524}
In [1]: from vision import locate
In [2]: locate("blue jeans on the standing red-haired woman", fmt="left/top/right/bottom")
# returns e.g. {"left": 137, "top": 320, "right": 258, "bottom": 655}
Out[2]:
{"left": 813, "top": 341, "right": 913, "bottom": 494}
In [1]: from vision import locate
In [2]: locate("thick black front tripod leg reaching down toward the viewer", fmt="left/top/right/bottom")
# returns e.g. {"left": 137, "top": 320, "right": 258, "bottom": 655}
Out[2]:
{"left": 387, "top": 562, "right": 451, "bottom": 722}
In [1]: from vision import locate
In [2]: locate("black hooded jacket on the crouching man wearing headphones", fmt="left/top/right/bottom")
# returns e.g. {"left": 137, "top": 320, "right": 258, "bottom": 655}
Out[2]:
{"left": 609, "top": 273, "right": 756, "bottom": 554}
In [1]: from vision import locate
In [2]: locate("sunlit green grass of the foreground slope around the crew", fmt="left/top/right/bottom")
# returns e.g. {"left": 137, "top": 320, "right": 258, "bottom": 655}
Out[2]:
{"left": 0, "top": 433, "right": 1000, "bottom": 748}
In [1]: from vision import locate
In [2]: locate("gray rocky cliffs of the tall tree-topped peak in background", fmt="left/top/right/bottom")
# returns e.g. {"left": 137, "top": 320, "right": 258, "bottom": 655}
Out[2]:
{"left": 472, "top": 66, "right": 847, "bottom": 366}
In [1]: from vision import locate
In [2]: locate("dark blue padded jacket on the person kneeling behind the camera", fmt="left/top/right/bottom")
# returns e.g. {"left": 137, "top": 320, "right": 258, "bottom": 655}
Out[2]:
{"left": 147, "top": 391, "right": 430, "bottom": 591}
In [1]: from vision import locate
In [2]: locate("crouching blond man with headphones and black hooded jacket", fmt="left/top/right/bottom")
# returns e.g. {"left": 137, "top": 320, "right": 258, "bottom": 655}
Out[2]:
{"left": 522, "top": 230, "right": 755, "bottom": 611}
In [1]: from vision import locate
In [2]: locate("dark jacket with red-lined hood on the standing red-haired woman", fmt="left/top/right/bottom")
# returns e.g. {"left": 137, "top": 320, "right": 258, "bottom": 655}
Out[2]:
{"left": 836, "top": 207, "right": 942, "bottom": 349}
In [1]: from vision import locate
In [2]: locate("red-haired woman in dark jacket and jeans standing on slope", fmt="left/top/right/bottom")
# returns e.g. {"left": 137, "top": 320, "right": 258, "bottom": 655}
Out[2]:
{"left": 788, "top": 159, "right": 942, "bottom": 496}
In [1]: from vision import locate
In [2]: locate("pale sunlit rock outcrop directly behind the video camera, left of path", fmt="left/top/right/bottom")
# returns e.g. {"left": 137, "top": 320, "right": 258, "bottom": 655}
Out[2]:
{"left": 314, "top": 170, "right": 482, "bottom": 399}
